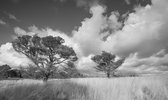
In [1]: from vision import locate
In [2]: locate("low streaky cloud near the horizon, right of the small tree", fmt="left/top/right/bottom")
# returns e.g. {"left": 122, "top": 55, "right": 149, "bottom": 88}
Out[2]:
{"left": 120, "top": 50, "right": 168, "bottom": 72}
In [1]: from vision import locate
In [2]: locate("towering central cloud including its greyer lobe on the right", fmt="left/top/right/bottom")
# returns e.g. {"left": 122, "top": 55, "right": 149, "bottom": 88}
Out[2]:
{"left": 73, "top": 5, "right": 122, "bottom": 56}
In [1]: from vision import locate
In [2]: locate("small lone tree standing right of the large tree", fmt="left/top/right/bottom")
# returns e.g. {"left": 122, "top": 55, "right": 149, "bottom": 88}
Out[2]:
{"left": 91, "top": 51, "right": 125, "bottom": 78}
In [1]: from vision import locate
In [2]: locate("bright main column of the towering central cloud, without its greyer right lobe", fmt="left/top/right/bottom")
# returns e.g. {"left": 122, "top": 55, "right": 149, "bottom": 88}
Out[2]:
{"left": 73, "top": 6, "right": 106, "bottom": 56}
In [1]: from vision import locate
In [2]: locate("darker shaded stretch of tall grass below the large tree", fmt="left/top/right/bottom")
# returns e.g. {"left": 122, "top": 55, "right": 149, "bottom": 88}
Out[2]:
{"left": 0, "top": 80, "right": 88, "bottom": 100}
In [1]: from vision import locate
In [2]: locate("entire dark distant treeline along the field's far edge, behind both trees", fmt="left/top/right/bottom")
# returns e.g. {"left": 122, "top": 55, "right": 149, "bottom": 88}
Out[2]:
{"left": 0, "top": 65, "right": 139, "bottom": 79}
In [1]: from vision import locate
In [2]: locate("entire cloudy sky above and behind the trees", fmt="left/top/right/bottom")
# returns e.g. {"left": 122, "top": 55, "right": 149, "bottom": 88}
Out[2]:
{"left": 0, "top": 0, "right": 168, "bottom": 72}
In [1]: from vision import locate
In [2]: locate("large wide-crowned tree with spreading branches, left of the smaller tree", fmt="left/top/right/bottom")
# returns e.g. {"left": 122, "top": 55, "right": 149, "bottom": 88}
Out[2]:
{"left": 12, "top": 35, "right": 77, "bottom": 81}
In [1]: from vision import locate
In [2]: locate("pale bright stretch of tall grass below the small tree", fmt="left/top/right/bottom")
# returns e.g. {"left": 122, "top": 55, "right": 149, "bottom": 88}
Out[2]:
{"left": 76, "top": 77, "right": 168, "bottom": 100}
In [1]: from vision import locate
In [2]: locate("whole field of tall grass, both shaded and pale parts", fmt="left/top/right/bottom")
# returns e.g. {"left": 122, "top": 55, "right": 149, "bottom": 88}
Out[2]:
{"left": 0, "top": 76, "right": 168, "bottom": 100}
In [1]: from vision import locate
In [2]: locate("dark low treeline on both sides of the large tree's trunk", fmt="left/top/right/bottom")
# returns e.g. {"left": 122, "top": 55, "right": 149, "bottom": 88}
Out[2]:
{"left": 0, "top": 65, "right": 84, "bottom": 79}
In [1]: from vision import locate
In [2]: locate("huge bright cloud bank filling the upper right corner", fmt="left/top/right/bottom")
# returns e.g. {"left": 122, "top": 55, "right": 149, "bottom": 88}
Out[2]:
{"left": 103, "top": 0, "right": 168, "bottom": 57}
